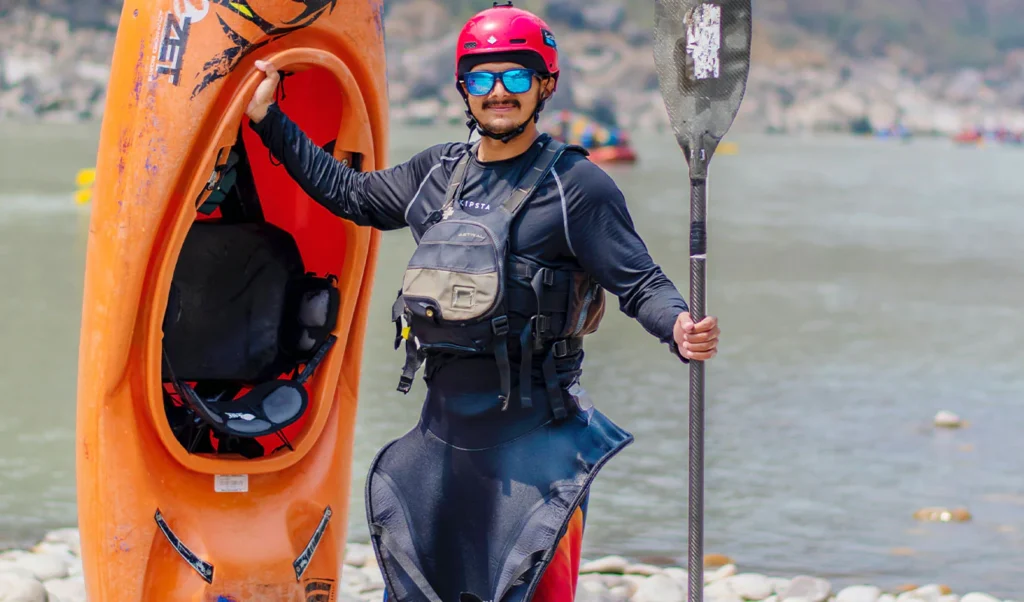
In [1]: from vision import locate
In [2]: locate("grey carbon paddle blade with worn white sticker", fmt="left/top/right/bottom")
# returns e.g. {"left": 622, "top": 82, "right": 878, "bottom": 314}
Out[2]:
{"left": 654, "top": 0, "right": 752, "bottom": 177}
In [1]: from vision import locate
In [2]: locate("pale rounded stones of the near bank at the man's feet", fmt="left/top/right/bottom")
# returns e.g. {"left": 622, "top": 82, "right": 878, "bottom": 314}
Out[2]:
{"left": 0, "top": 528, "right": 1012, "bottom": 602}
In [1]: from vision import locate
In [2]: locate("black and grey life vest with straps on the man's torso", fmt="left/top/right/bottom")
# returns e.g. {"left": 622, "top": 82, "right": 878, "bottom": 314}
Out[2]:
{"left": 391, "top": 134, "right": 604, "bottom": 419}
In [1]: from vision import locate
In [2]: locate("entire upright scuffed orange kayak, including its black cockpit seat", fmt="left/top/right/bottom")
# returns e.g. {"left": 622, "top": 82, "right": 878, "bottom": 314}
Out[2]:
{"left": 76, "top": 0, "right": 388, "bottom": 602}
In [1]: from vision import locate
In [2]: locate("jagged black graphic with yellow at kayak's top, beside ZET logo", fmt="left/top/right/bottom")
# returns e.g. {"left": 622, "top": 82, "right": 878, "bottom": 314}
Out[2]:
{"left": 191, "top": 0, "right": 338, "bottom": 98}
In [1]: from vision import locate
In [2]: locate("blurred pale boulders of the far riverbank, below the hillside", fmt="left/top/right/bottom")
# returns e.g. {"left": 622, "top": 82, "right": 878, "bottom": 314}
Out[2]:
{"left": 6, "top": 0, "right": 1024, "bottom": 134}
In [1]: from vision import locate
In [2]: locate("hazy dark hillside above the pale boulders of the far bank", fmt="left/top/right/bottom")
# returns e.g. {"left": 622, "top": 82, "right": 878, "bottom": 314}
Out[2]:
{"left": 19, "top": 0, "right": 1024, "bottom": 71}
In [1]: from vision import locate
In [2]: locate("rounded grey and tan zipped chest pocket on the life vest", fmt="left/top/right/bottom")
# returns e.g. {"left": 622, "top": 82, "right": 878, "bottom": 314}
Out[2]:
{"left": 402, "top": 220, "right": 505, "bottom": 330}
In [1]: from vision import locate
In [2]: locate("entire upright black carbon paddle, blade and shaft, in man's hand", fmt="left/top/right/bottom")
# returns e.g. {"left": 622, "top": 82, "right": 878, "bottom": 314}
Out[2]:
{"left": 654, "top": 0, "right": 752, "bottom": 602}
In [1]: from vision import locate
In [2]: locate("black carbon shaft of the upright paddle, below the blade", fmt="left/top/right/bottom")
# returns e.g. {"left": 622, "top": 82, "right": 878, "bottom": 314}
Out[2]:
{"left": 686, "top": 179, "right": 708, "bottom": 602}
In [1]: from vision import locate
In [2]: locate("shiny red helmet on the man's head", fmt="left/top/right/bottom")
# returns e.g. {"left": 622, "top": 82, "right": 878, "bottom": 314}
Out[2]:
{"left": 455, "top": 2, "right": 558, "bottom": 82}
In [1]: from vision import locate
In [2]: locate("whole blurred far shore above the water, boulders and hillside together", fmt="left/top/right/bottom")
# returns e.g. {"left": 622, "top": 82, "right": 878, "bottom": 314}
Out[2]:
{"left": 0, "top": 0, "right": 1024, "bottom": 133}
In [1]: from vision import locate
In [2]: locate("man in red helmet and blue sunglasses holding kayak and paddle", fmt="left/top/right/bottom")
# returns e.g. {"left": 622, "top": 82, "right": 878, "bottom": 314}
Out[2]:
{"left": 247, "top": 3, "right": 719, "bottom": 602}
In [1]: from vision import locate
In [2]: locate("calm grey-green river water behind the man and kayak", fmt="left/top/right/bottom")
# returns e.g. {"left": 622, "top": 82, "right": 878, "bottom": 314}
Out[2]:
{"left": 0, "top": 124, "right": 1024, "bottom": 598}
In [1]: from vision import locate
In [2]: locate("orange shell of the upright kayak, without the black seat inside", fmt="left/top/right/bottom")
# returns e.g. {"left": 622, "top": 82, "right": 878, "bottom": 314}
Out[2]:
{"left": 76, "top": 0, "right": 388, "bottom": 602}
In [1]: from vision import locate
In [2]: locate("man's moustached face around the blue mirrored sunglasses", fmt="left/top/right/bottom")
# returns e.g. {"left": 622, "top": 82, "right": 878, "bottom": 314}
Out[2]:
{"left": 463, "top": 62, "right": 554, "bottom": 134}
